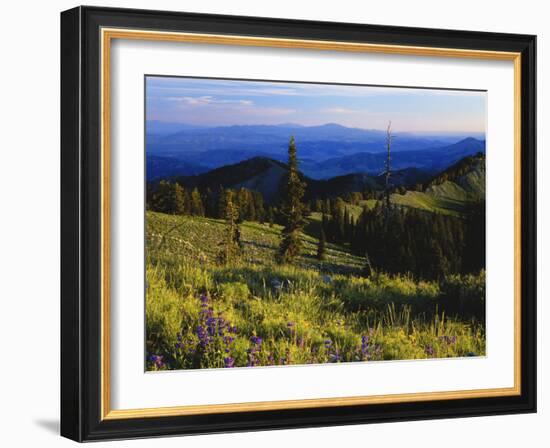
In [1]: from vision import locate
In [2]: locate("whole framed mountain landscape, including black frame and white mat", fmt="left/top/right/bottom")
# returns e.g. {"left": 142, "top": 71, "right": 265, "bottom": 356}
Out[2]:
{"left": 61, "top": 7, "right": 536, "bottom": 441}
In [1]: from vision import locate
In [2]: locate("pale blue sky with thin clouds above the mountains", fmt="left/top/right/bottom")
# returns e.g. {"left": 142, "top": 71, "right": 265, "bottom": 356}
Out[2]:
{"left": 146, "top": 76, "right": 486, "bottom": 133}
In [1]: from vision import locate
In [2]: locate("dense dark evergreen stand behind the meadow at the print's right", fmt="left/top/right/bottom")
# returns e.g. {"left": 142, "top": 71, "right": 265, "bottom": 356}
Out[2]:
{"left": 322, "top": 198, "right": 485, "bottom": 279}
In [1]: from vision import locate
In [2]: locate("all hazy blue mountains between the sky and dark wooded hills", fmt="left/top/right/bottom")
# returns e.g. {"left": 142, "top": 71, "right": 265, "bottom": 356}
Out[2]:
{"left": 146, "top": 121, "right": 485, "bottom": 180}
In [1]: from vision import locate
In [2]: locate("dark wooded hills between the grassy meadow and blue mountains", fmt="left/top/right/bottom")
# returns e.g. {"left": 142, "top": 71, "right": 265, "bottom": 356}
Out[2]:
{"left": 148, "top": 150, "right": 485, "bottom": 279}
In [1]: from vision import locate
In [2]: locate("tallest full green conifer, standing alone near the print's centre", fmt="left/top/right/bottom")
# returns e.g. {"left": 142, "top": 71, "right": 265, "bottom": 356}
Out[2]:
{"left": 278, "top": 137, "right": 305, "bottom": 263}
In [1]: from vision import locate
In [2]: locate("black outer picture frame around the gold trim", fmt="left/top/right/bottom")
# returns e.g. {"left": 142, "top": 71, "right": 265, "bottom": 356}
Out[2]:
{"left": 61, "top": 7, "right": 537, "bottom": 441}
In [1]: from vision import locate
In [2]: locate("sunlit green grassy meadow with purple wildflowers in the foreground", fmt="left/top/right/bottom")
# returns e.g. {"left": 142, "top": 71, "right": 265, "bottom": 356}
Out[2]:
{"left": 146, "top": 211, "right": 485, "bottom": 370}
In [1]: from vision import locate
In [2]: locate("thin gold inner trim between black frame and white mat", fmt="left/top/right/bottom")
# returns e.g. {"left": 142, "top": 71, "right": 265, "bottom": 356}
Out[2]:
{"left": 100, "top": 28, "right": 521, "bottom": 420}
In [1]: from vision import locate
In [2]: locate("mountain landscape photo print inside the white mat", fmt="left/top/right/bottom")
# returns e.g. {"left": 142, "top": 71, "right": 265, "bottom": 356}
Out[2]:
{"left": 145, "top": 76, "right": 487, "bottom": 371}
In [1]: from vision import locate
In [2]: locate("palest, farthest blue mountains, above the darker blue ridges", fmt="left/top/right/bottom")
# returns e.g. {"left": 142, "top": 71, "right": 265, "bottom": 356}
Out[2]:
{"left": 146, "top": 122, "right": 484, "bottom": 169}
